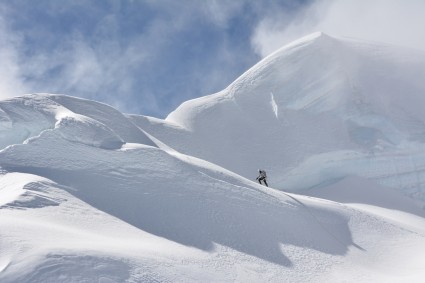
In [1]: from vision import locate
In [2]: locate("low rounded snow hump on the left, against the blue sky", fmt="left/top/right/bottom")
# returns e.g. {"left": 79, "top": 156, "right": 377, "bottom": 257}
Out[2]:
{"left": 0, "top": 94, "right": 154, "bottom": 149}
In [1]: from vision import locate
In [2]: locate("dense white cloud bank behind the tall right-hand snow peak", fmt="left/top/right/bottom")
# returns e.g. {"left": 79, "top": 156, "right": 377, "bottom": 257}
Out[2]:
{"left": 252, "top": 0, "right": 425, "bottom": 57}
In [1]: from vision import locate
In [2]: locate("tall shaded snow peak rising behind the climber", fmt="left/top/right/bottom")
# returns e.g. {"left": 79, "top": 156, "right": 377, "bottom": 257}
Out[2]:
{"left": 135, "top": 33, "right": 425, "bottom": 203}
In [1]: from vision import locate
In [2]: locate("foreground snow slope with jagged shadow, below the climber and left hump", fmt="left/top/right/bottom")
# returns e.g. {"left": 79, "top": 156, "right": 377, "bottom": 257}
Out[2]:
{"left": 0, "top": 116, "right": 425, "bottom": 282}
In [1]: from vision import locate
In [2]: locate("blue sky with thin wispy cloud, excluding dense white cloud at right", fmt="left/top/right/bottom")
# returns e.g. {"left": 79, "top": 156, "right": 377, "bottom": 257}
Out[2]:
{"left": 0, "top": 0, "right": 308, "bottom": 117}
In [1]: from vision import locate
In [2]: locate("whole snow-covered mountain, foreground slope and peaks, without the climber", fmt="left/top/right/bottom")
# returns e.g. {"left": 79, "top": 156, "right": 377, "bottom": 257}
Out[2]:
{"left": 0, "top": 33, "right": 425, "bottom": 283}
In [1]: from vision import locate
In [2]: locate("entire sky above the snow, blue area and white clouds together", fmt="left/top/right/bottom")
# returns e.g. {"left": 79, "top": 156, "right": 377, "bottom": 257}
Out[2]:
{"left": 0, "top": 0, "right": 425, "bottom": 118}
